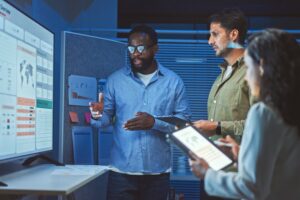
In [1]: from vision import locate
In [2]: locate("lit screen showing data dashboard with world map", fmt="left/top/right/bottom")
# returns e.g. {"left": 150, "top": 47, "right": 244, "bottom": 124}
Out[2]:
{"left": 0, "top": 0, "right": 54, "bottom": 161}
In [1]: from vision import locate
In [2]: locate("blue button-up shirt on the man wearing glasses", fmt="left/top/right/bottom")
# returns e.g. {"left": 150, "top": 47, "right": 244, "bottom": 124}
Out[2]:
{"left": 91, "top": 63, "right": 190, "bottom": 174}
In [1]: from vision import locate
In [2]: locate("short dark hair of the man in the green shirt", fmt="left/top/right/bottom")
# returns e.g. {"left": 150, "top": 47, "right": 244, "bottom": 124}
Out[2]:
{"left": 209, "top": 8, "right": 248, "bottom": 45}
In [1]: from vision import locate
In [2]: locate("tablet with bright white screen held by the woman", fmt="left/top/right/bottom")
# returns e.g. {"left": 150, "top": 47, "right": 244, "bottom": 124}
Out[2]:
{"left": 170, "top": 126, "right": 233, "bottom": 170}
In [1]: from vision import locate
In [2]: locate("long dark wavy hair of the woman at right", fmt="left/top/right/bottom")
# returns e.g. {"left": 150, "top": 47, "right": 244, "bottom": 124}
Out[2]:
{"left": 247, "top": 29, "right": 300, "bottom": 134}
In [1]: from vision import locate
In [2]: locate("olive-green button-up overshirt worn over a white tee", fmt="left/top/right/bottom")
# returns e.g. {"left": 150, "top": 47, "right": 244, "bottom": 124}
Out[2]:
{"left": 208, "top": 58, "right": 253, "bottom": 141}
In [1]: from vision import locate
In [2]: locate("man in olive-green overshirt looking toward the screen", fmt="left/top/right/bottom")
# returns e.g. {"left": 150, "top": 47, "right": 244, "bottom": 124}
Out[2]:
{"left": 193, "top": 9, "right": 252, "bottom": 141}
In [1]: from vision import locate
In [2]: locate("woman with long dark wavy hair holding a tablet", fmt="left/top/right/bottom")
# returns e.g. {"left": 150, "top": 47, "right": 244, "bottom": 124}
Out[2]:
{"left": 190, "top": 29, "right": 300, "bottom": 200}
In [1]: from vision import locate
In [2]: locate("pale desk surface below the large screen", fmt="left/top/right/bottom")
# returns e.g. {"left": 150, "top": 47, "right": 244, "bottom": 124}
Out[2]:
{"left": 0, "top": 164, "right": 108, "bottom": 195}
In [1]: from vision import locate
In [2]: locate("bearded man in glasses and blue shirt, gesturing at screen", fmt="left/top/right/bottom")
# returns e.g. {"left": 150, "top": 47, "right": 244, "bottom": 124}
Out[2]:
{"left": 90, "top": 25, "right": 190, "bottom": 200}
